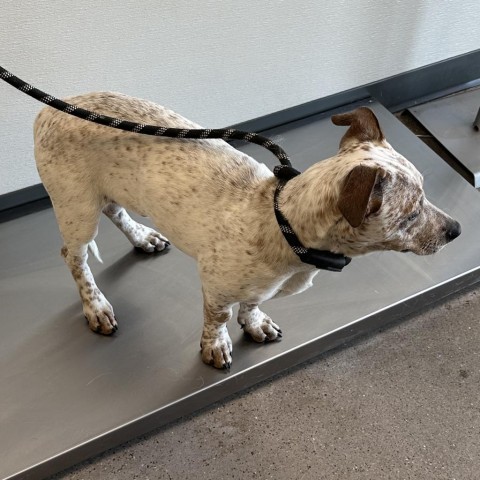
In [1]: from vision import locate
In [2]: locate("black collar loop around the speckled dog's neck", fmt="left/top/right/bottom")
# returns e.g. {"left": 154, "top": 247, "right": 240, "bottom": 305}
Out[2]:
{"left": 273, "top": 165, "right": 352, "bottom": 272}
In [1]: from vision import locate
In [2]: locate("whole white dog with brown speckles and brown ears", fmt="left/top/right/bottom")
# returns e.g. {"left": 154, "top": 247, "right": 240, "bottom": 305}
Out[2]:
{"left": 34, "top": 92, "right": 461, "bottom": 368}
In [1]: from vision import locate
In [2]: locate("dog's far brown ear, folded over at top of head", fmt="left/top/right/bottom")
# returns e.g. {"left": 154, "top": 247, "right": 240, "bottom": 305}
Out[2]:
{"left": 332, "top": 107, "right": 385, "bottom": 148}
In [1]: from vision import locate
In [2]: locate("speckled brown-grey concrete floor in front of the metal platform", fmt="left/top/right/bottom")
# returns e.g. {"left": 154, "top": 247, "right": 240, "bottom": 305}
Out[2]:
{"left": 50, "top": 288, "right": 480, "bottom": 480}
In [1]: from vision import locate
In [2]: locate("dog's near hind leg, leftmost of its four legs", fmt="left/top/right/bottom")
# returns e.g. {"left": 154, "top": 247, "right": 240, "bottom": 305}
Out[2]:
{"left": 54, "top": 202, "right": 117, "bottom": 335}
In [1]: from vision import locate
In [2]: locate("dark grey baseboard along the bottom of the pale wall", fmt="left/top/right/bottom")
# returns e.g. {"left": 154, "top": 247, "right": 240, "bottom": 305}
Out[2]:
{"left": 0, "top": 49, "right": 480, "bottom": 214}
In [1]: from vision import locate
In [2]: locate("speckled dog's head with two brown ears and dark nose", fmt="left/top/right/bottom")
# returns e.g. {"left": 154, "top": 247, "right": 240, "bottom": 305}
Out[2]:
{"left": 310, "top": 107, "right": 461, "bottom": 256}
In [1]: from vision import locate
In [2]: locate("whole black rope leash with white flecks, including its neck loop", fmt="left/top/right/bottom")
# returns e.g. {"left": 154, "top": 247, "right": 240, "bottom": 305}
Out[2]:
{"left": 0, "top": 66, "right": 351, "bottom": 272}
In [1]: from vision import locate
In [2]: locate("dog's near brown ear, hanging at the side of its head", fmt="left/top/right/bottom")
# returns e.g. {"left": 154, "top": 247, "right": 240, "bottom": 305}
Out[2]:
{"left": 337, "top": 165, "right": 385, "bottom": 228}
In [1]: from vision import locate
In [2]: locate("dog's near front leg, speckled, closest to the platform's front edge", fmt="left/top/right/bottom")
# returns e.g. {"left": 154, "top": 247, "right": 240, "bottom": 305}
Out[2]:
{"left": 200, "top": 293, "right": 232, "bottom": 369}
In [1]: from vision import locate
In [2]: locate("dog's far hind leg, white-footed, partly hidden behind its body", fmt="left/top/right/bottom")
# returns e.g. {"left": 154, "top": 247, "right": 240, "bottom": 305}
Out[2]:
{"left": 103, "top": 203, "right": 170, "bottom": 252}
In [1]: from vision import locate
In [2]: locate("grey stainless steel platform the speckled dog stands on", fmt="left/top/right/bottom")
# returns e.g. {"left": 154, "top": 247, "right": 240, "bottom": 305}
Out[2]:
{"left": 0, "top": 102, "right": 480, "bottom": 479}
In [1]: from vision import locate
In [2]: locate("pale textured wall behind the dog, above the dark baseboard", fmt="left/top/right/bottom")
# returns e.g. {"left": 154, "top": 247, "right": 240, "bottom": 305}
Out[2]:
{"left": 0, "top": 0, "right": 480, "bottom": 194}
